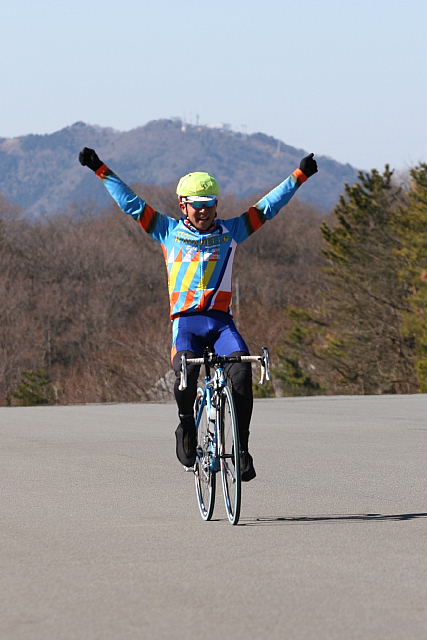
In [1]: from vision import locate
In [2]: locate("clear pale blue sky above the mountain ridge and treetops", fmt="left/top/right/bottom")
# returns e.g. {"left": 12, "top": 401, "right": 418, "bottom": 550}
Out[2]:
{"left": 0, "top": 0, "right": 427, "bottom": 171}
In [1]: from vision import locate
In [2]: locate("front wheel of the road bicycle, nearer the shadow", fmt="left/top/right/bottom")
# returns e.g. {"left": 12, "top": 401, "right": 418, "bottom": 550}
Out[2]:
{"left": 219, "top": 387, "right": 241, "bottom": 524}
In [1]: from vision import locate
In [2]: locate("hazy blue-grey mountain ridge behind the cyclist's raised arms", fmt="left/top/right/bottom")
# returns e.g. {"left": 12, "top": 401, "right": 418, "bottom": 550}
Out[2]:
{"left": 0, "top": 118, "right": 357, "bottom": 216}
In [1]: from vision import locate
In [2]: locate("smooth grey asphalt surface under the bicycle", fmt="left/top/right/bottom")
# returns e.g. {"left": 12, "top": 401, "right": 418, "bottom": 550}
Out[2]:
{"left": 0, "top": 396, "right": 427, "bottom": 640}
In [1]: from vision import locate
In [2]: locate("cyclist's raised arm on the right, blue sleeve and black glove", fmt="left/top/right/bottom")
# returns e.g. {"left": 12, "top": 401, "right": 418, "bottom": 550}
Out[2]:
{"left": 226, "top": 153, "right": 317, "bottom": 243}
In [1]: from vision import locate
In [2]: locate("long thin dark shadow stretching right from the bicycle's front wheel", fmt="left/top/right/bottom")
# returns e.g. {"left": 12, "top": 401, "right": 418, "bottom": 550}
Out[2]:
{"left": 240, "top": 513, "right": 427, "bottom": 526}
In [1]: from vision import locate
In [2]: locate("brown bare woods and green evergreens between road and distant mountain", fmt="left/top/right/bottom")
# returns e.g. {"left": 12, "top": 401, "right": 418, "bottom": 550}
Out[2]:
{"left": 0, "top": 165, "right": 427, "bottom": 404}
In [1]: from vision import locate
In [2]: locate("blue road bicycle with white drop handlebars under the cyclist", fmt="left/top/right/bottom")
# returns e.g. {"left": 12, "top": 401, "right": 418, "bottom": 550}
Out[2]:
{"left": 179, "top": 347, "right": 270, "bottom": 525}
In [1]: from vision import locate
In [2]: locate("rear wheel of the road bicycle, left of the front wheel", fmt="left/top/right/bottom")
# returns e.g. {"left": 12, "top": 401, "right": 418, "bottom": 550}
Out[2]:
{"left": 194, "top": 389, "right": 216, "bottom": 520}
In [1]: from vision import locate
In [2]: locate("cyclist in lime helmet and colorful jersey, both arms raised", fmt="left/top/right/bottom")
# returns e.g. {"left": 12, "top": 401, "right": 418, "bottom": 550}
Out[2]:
{"left": 79, "top": 147, "right": 317, "bottom": 481}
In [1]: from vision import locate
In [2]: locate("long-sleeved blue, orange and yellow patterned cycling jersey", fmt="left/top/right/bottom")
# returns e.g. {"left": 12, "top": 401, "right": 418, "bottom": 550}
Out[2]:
{"left": 96, "top": 164, "right": 307, "bottom": 319}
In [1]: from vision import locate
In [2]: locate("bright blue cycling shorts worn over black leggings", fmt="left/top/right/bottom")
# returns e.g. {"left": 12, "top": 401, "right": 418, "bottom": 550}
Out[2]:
{"left": 172, "top": 311, "right": 249, "bottom": 360}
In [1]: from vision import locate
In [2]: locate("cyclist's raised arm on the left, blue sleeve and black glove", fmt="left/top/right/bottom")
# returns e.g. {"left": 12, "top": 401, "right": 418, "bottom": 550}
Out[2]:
{"left": 79, "top": 147, "right": 177, "bottom": 242}
